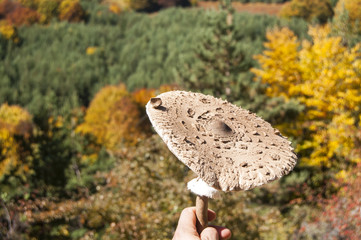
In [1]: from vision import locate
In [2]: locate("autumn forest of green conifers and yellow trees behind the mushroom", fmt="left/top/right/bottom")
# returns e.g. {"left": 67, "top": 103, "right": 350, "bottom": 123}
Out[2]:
{"left": 0, "top": 0, "right": 361, "bottom": 240}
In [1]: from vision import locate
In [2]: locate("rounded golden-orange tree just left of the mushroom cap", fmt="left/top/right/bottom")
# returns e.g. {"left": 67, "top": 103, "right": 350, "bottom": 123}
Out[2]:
{"left": 76, "top": 85, "right": 141, "bottom": 151}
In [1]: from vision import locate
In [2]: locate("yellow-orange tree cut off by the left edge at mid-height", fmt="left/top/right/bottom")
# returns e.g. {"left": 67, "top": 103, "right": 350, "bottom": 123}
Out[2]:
{"left": 0, "top": 104, "right": 32, "bottom": 180}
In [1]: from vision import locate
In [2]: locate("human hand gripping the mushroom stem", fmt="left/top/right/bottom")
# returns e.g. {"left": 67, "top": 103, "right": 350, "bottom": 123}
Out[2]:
{"left": 173, "top": 207, "right": 231, "bottom": 240}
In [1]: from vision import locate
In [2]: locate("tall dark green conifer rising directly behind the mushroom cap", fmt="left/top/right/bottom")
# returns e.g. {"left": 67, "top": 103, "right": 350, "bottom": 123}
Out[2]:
{"left": 176, "top": 1, "right": 246, "bottom": 101}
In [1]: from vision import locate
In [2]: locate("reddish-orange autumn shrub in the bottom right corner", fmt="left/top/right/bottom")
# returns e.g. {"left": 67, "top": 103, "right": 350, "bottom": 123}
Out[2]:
{"left": 300, "top": 165, "right": 361, "bottom": 239}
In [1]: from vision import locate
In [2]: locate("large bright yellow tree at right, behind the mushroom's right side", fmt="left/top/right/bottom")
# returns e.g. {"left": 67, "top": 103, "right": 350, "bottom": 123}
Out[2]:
{"left": 253, "top": 25, "right": 361, "bottom": 167}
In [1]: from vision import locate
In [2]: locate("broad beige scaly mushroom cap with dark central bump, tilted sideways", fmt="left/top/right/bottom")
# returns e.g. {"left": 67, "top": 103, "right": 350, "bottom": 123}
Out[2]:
{"left": 146, "top": 91, "right": 297, "bottom": 191}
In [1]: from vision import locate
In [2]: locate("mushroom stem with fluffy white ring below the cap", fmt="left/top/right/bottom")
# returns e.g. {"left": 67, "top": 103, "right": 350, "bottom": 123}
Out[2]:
{"left": 187, "top": 178, "right": 219, "bottom": 234}
